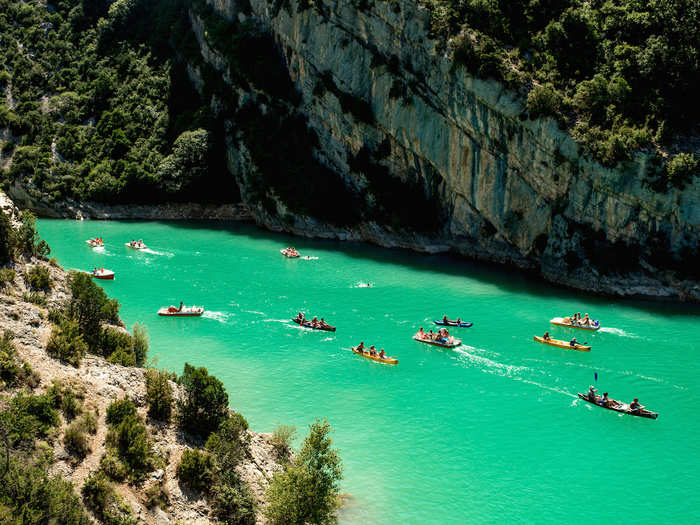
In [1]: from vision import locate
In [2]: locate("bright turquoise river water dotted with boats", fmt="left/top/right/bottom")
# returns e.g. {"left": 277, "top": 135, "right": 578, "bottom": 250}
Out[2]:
{"left": 39, "top": 220, "right": 700, "bottom": 524}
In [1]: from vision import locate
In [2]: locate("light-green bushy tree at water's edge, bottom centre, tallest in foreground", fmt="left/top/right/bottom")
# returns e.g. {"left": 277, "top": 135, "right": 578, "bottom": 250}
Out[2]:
{"left": 265, "top": 420, "right": 343, "bottom": 525}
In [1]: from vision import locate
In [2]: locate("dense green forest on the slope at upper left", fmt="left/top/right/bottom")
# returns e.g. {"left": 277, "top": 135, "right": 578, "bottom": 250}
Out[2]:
{"left": 0, "top": 0, "right": 237, "bottom": 202}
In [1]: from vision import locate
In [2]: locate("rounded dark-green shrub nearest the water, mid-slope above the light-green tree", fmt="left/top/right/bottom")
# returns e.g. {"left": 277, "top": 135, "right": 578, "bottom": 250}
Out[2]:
{"left": 180, "top": 363, "right": 228, "bottom": 439}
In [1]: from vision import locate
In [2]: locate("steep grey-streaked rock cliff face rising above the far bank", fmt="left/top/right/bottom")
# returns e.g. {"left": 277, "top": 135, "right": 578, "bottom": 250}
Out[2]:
{"left": 188, "top": 0, "right": 700, "bottom": 301}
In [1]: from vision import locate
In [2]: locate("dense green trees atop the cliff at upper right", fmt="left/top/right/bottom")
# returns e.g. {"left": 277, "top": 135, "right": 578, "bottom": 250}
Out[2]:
{"left": 420, "top": 0, "right": 700, "bottom": 176}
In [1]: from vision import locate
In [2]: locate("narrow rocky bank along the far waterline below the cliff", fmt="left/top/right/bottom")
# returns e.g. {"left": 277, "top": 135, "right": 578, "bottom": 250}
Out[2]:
{"left": 10, "top": 183, "right": 700, "bottom": 303}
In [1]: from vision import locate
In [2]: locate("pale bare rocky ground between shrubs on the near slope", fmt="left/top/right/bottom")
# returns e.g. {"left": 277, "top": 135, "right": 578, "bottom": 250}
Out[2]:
{"left": 0, "top": 193, "right": 280, "bottom": 525}
